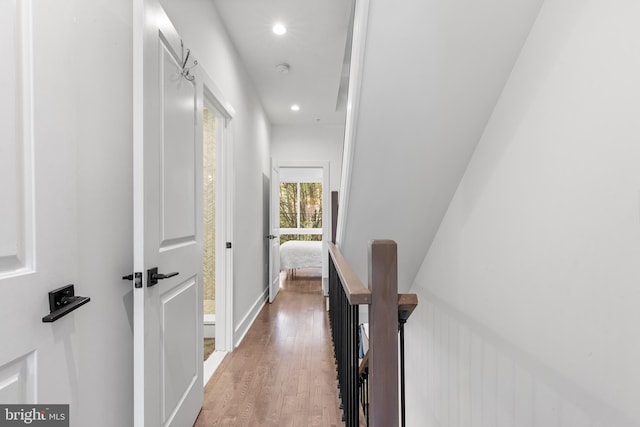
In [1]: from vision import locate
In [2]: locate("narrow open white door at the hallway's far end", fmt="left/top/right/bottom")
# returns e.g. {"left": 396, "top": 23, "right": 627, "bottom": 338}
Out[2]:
{"left": 269, "top": 161, "right": 280, "bottom": 302}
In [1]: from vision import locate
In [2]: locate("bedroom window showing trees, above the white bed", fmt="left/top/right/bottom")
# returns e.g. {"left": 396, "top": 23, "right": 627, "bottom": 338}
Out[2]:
{"left": 280, "top": 182, "right": 322, "bottom": 243}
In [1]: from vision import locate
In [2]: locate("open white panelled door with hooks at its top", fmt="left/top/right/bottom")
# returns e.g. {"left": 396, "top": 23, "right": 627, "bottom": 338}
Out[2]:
{"left": 134, "top": 0, "right": 203, "bottom": 427}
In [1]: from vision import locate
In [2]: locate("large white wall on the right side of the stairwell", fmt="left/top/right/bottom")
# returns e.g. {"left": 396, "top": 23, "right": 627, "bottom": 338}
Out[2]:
{"left": 406, "top": 0, "right": 640, "bottom": 427}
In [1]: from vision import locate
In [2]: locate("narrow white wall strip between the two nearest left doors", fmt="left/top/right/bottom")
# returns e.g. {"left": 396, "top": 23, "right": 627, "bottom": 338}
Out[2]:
{"left": 74, "top": 0, "right": 133, "bottom": 427}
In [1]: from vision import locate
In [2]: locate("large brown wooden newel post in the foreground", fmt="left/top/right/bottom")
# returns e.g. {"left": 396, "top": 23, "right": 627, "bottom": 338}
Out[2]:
{"left": 369, "top": 240, "right": 399, "bottom": 427}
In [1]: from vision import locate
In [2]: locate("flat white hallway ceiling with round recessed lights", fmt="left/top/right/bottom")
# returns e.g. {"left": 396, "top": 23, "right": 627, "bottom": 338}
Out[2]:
{"left": 213, "top": 0, "right": 353, "bottom": 124}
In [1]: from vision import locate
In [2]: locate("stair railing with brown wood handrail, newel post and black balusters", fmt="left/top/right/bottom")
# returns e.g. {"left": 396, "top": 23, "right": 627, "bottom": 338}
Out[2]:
{"left": 329, "top": 240, "right": 417, "bottom": 427}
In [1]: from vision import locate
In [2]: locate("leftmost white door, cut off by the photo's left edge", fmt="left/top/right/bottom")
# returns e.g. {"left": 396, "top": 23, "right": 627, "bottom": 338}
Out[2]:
{"left": 0, "top": 1, "right": 79, "bottom": 412}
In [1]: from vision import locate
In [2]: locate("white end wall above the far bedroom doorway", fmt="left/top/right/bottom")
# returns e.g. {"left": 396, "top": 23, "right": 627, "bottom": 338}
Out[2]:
{"left": 271, "top": 125, "right": 344, "bottom": 191}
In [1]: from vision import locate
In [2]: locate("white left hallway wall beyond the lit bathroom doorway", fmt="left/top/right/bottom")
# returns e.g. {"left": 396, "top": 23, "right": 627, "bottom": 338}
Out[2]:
{"left": 161, "top": 0, "right": 271, "bottom": 340}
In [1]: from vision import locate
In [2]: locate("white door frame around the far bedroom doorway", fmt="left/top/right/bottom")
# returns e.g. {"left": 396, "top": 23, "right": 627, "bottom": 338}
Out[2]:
{"left": 278, "top": 160, "right": 331, "bottom": 296}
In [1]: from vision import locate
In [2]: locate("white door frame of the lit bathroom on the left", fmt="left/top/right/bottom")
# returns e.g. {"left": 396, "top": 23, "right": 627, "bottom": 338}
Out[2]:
{"left": 199, "top": 69, "right": 236, "bottom": 354}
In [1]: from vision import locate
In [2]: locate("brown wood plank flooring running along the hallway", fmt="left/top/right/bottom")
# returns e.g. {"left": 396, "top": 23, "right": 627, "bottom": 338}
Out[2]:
{"left": 194, "top": 270, "right": 343, "bottom": 427}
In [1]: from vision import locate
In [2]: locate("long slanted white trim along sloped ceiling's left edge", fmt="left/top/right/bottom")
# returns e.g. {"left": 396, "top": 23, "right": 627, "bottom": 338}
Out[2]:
{"left": 336, "top": 0, "right": 369, "bottom": 245}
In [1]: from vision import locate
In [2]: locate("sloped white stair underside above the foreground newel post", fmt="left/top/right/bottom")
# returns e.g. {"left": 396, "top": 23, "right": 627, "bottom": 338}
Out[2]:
{"left": 339, "top": 0, "right": 542, "bottom": 291}
